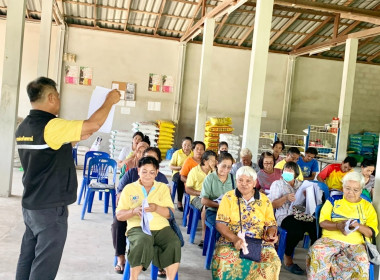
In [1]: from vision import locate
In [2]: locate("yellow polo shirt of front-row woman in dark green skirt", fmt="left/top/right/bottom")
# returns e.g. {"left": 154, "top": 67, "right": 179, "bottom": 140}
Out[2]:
{"left": 116, "top": 181, "right": 174, "bottom": 235}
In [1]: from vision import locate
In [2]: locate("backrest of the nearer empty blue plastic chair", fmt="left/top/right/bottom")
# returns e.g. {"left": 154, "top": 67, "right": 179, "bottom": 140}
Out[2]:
{"left": 87, "top": 157, "right": 117, "bottom": 185}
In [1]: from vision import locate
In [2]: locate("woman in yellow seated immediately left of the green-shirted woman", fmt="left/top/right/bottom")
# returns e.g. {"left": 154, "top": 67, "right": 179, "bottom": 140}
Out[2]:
{"left": 186, "top": 151, "right": 216, "bottom": 248}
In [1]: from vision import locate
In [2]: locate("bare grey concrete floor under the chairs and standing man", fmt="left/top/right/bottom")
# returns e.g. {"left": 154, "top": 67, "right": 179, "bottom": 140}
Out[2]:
{"left": 0, "top": 168, "right": 306, "bottom": 280}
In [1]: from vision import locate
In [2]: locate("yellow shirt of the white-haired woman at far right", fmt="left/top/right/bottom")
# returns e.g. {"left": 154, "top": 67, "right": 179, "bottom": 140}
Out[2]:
{"left": 319, "top": 198, "right": 379, "bottom": 244}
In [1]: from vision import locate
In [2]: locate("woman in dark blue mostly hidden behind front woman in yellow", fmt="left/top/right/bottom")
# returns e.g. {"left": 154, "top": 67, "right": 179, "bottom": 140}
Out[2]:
{"left": 112, "top": 147, "right": 169, "bottom": 274}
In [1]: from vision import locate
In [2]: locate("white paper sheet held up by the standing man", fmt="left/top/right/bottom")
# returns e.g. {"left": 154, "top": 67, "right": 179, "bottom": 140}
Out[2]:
{"left": 87, "top": 86, "right": 115, "bottom": 133}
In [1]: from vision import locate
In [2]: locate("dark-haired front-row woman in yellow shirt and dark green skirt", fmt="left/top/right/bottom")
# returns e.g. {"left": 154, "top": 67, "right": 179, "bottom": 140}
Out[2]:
{"left": 116, "top": 157, "right": 181, "bottom": 280}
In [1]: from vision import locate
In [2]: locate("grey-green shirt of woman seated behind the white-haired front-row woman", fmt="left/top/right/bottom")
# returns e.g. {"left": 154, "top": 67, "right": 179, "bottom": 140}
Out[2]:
{"left": 200, "top": 171, "right": 235, "bottom": 211}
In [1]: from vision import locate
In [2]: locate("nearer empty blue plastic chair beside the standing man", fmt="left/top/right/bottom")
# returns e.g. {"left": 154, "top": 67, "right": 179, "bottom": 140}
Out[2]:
{"left": 81, "top": 158, "right": 117, "bottom": 220}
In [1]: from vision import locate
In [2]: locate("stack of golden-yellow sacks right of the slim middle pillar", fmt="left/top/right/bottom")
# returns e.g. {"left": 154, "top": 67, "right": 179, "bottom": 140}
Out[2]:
{"left": 205, "top": 117, "right": 234, "bottom": 153}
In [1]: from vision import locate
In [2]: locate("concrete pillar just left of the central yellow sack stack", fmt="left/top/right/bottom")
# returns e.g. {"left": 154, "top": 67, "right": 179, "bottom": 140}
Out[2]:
{"left": 194, "top": 18, "right": 215, "bottom": 141}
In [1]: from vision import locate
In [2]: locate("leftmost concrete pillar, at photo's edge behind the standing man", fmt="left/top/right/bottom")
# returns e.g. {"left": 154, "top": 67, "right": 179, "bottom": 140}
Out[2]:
{"left": 0, "top": 0, "right": 26, "bottom": 197}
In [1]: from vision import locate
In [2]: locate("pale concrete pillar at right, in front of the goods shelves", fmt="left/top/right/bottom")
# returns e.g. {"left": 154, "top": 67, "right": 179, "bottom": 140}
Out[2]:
{"left": 337, "top": 39, "right": 358, "bottom": 161}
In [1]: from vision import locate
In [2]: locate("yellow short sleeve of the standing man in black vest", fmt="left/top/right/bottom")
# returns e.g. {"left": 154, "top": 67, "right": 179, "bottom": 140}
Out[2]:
{"left": 44, "top": 118, "right": 83, "bottom": 150}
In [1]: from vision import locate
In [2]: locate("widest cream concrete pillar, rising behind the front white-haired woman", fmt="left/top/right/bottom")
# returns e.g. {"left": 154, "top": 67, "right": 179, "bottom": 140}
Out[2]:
{"left": 242, "top": 0, "right": 274, "bottom": 162}
